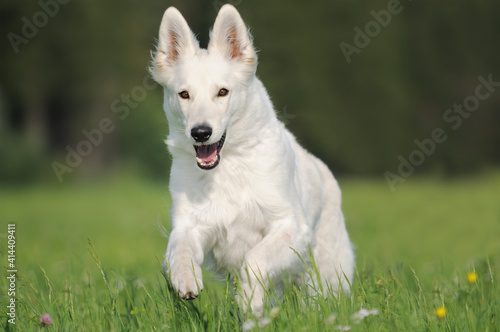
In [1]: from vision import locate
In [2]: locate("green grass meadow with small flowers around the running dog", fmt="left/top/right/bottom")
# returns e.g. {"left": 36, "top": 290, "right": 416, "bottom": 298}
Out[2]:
{"left": 0, "top": 173, "right": 500, "bottom": 331}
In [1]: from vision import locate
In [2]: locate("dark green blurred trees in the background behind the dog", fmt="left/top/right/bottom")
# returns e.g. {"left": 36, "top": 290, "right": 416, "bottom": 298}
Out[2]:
{"left": 0, "top": 0, "right": 500, "bottom": 183}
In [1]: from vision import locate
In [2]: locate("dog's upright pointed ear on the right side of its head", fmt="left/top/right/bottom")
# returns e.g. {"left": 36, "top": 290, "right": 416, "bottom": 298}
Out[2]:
{"left": 208, "top": 4, "right": 257, "bottom": 66}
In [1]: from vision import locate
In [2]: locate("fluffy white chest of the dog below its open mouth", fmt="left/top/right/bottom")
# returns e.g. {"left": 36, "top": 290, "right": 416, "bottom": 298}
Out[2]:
{"left": 175, "top": 158, "right": 283, "bottom": 270}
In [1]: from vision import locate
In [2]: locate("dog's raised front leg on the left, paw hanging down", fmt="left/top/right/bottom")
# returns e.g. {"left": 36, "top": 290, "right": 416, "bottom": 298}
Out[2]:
{"left": 165, "top": 229, "right": 204, "bottom": 300}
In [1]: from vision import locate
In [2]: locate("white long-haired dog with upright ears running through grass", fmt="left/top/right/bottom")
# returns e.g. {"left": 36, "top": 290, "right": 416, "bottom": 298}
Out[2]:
{"left": 151, "top": 5, "right": 354, "bottom": 316}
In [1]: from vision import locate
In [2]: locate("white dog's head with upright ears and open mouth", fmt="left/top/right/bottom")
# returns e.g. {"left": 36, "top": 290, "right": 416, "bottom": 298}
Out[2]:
{"left": 151, "top": 5, "right": 257, "bottom": 170}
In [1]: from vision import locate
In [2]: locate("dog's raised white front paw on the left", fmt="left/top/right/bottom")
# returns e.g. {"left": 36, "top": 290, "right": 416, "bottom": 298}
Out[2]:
{"left": 170, "top": 264, "right": 203, "bottom": 300}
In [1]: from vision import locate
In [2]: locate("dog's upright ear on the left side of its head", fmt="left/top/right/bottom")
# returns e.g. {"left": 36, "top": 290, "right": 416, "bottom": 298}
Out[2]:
{"left": 151, "top": 7, "right": 199, "bottom": 81}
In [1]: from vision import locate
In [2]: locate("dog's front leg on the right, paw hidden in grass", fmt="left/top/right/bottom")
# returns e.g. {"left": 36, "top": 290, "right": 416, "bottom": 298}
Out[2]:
{"left": 237, "top": 220, "right": 309, "bottom": 317}
